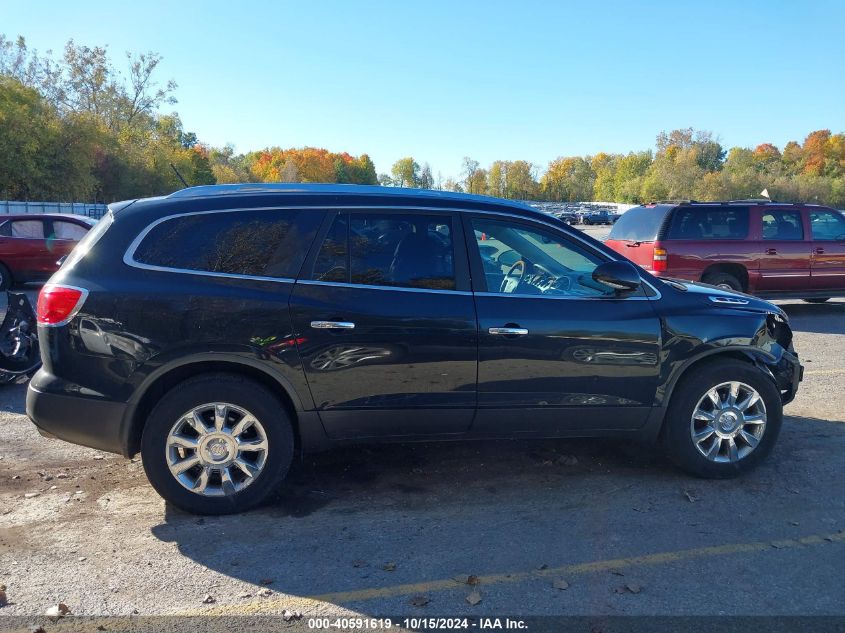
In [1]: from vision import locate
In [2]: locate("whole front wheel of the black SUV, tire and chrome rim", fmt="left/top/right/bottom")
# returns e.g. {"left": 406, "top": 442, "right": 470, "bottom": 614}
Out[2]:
{"left": 664, "top": 360, "right": 783, "bottom": 478}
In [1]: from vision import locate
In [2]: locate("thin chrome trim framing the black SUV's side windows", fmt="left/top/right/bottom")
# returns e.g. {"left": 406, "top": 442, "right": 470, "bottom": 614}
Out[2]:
{"left": 123, "top": 204, "right": 663, "bottom": 301}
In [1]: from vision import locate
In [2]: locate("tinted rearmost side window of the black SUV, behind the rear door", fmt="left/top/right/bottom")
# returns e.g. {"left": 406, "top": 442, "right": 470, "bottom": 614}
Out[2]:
{"left": 134, "top": 209, "right": 322, "bottom": 278}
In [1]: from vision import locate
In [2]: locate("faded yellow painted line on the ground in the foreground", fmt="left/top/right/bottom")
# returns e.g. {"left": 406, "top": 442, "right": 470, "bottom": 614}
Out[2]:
{"left": 186, "top": 532, "right": 845, "bottom": 615}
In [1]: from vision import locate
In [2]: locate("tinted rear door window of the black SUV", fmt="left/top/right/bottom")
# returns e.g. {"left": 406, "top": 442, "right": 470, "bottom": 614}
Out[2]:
{"left": 312, "top": 213, "right": 456, "bottom": 290}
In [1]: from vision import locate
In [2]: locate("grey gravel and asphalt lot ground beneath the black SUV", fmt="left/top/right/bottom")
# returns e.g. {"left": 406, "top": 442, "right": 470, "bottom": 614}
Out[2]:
{"left": 0, "top": 229, "right": 845, "bottom": 627}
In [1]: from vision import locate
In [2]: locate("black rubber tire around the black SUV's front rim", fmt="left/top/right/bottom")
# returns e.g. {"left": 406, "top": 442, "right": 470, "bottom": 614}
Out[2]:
{"left": 663, "top": 360, "right": 783, "bottom": 479}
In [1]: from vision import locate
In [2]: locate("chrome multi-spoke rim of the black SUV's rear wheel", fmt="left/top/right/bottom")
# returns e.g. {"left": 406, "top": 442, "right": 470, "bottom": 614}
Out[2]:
{"left": 165, "top": 402, "right": 268, "bottom": 497}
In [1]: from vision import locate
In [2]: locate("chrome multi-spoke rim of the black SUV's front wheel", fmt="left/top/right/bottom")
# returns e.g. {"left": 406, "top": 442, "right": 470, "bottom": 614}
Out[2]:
{"left": 690, "top": 381, "right": 766, "bottom": 462}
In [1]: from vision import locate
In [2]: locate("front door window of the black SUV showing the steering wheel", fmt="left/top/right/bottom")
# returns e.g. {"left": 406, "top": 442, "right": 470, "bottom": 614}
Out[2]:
{"left": 472, "top": 219, "right": 613, "bottom": 297}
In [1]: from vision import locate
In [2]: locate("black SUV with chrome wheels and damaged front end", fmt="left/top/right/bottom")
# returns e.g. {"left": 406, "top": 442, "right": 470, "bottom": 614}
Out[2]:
{"left": 27, "top": 185, "right": 801, "bottom": 513}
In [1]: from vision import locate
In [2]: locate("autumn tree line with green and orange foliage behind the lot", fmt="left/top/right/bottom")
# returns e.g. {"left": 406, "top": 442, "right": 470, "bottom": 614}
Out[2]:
{"left": 0, "top": 34, "right": 845, "bottom": 207}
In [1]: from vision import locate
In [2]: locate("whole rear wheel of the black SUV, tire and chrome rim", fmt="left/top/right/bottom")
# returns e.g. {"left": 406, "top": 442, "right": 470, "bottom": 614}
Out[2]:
{"left": 141, "top": 374, "right": 294, "bottom": 514}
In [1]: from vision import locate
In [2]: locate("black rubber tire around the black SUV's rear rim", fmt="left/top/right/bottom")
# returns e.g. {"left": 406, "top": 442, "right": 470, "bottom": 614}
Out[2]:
{"left": 141, "top": 373, "right": 294, "bottom": 514}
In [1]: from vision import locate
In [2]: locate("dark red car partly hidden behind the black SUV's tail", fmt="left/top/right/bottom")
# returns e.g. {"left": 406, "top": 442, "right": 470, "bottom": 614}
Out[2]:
{"left": 0, "top": 213, "right": 97, "bottom": 290}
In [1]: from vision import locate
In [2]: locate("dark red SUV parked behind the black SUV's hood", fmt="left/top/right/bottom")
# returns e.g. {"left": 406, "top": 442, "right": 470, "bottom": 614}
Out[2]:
{"left": 606, "top": 200, "right": 845, "bottom": 302}
